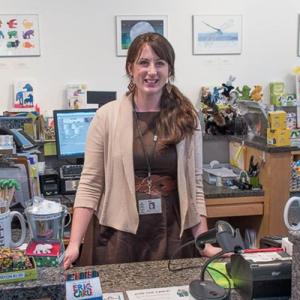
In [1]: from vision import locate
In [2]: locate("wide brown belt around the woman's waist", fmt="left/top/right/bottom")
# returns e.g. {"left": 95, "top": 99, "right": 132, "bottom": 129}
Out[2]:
{"left": 135, "top": 175, "right": 177, "bottom": 196}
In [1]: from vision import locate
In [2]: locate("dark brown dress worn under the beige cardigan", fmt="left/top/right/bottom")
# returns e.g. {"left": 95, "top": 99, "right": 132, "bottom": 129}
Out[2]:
{"left": 81, "top": 112, "right": 198, "bottom": 264}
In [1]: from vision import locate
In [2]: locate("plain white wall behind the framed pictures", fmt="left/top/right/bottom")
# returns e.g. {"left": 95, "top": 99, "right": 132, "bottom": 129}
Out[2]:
{"left": 0, "top": 0, "right": 300, "bottom": 114}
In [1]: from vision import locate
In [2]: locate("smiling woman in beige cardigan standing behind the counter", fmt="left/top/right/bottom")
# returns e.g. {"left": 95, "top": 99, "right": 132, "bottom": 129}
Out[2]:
{"left": 64, "top": 33, "right": 220, "bottom": 268}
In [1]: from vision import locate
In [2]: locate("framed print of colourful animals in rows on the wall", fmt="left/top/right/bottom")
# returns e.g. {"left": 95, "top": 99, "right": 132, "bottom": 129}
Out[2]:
{"left": 0, "top": 14, "right": 40, "bottom": 56}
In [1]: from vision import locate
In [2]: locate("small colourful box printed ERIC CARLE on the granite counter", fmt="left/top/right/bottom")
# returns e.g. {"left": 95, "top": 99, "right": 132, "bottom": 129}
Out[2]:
{"left": 66, "top": 271, "right": 103, "bottom": 300}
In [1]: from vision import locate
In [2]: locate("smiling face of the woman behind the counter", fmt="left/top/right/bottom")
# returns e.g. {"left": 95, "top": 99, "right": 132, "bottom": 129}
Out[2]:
{"left": 129, "top": 44, "right": 169, "bottom": 97}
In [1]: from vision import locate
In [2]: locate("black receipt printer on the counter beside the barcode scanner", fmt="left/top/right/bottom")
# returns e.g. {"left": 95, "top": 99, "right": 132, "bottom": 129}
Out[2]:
{"left": 230, "top": 251, "right": 292, "bottom": 300}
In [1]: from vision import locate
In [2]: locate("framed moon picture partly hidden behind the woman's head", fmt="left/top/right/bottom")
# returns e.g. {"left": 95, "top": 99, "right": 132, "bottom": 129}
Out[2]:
{"left": 116, "top": 16, "right": 167, "bottom": 56}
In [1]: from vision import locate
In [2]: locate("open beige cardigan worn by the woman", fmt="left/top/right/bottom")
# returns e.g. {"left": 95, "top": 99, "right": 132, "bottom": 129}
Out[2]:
{"left": 74, "top": 96, "right": 206, "bottom": 234}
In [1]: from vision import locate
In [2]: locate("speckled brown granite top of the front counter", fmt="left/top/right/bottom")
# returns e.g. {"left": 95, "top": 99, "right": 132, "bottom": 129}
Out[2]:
{"left": 0, "top": 258, "right": 241, "bottom": 300}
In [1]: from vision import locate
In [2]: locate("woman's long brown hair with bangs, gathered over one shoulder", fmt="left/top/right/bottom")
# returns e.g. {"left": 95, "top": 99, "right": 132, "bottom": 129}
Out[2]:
{"left": 125, "top": 32, "right": 199, "bottom": 145}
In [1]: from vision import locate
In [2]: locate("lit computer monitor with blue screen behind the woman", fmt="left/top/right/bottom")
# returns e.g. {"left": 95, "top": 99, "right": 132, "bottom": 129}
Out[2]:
{"left": 53, "top": 109, "right": 96, "bottom": 159}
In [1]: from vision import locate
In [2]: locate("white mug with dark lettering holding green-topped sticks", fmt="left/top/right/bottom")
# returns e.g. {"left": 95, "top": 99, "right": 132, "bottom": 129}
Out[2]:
{"left": 0, "top": 211, "right": 26, "bottom": 248}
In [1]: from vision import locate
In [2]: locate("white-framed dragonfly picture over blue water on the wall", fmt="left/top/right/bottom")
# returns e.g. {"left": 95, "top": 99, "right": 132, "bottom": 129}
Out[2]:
{"left": 193, "top": 15, "right": 242, "bottom": 55}
